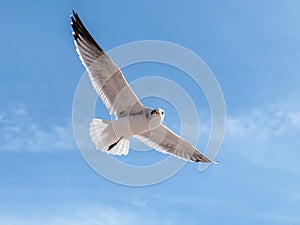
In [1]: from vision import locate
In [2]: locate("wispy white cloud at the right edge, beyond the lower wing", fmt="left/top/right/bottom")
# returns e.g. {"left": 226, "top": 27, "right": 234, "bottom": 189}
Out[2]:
{"left": 225, "top": 103, "right": 300, "bottom": 170}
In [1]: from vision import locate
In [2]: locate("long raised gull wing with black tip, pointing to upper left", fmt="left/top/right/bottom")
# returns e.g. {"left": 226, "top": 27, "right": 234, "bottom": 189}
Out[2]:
{"left": 71, "top": 11, "right": 144, "bottom": 118}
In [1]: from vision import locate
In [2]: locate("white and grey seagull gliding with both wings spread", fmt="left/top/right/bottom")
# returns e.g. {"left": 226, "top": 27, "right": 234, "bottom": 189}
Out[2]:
{"left": 71, "top": 10, "right": 216, "bottom": 163}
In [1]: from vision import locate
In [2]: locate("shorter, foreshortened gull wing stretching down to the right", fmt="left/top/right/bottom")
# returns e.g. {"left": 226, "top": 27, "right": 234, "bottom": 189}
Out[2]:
{"left": 134, "top": 124, "right": 215, "bottom": 163}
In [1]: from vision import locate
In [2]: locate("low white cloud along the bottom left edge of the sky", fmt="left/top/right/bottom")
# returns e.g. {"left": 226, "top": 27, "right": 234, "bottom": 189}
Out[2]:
{"left": 0, "top": 205, "right": 176, "bottom": 225}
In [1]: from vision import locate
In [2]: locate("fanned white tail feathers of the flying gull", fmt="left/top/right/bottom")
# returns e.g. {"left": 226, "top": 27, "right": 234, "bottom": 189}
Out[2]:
{"left": 90, "top": 119, "right": 130, "bottom": 155}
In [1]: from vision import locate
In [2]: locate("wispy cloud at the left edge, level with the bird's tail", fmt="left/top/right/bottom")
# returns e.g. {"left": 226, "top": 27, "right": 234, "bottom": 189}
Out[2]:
{"left": 0, "top": 104, "right": 75, "bottom": 151}
